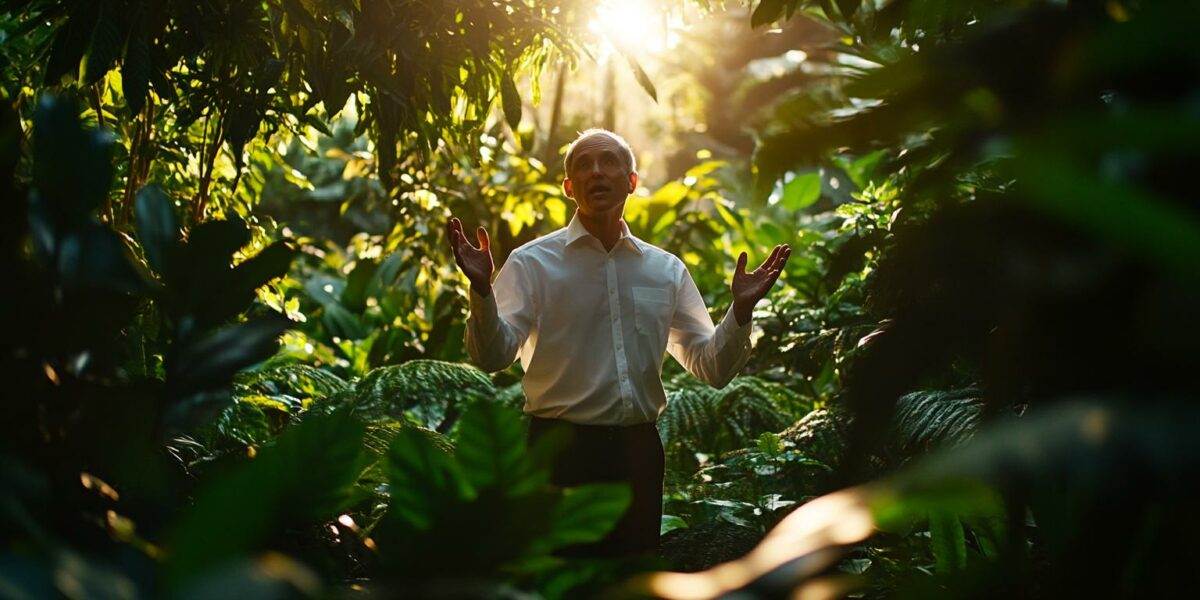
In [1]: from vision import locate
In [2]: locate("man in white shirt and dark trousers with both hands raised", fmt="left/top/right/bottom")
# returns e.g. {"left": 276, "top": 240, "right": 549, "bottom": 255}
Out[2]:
{"left": 448, "top": 130, "right": 792, "bottom": 556}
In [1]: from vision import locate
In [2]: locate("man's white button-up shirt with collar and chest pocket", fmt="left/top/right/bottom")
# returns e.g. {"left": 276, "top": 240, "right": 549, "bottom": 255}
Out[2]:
{"left": 466, "top": 216, "right": 751, "bottom": 425}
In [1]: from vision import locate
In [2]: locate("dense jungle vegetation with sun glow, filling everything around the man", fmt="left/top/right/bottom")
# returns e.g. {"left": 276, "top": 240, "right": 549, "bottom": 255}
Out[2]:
{"left": 0, "top": 0, "right": 1200, "bottom": 599}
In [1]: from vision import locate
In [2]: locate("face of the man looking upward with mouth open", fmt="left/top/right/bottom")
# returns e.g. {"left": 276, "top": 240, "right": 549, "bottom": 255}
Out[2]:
{"left": 563, "top": 136, "right": 637, "bottom": 217}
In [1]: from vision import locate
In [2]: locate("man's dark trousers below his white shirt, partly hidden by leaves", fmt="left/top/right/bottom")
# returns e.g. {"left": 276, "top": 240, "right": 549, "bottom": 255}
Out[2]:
{"left": 529, "top": 416, "right": 664, "bottom": 557}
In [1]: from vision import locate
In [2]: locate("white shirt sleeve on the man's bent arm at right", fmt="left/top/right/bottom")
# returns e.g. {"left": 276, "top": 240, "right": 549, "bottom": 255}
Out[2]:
{"left": 667, "top": 262, "right": 752, "bottom": 388}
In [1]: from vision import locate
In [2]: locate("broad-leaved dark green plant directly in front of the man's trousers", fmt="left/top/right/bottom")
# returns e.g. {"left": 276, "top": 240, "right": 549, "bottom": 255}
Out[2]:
{"left": 372, "top": 402, "right": 629, "bottom": 578}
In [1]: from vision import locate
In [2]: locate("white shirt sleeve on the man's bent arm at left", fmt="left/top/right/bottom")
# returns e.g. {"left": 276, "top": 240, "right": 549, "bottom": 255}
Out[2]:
{"left": 463, "top": 253, "right": 535, "bottom": 372}
